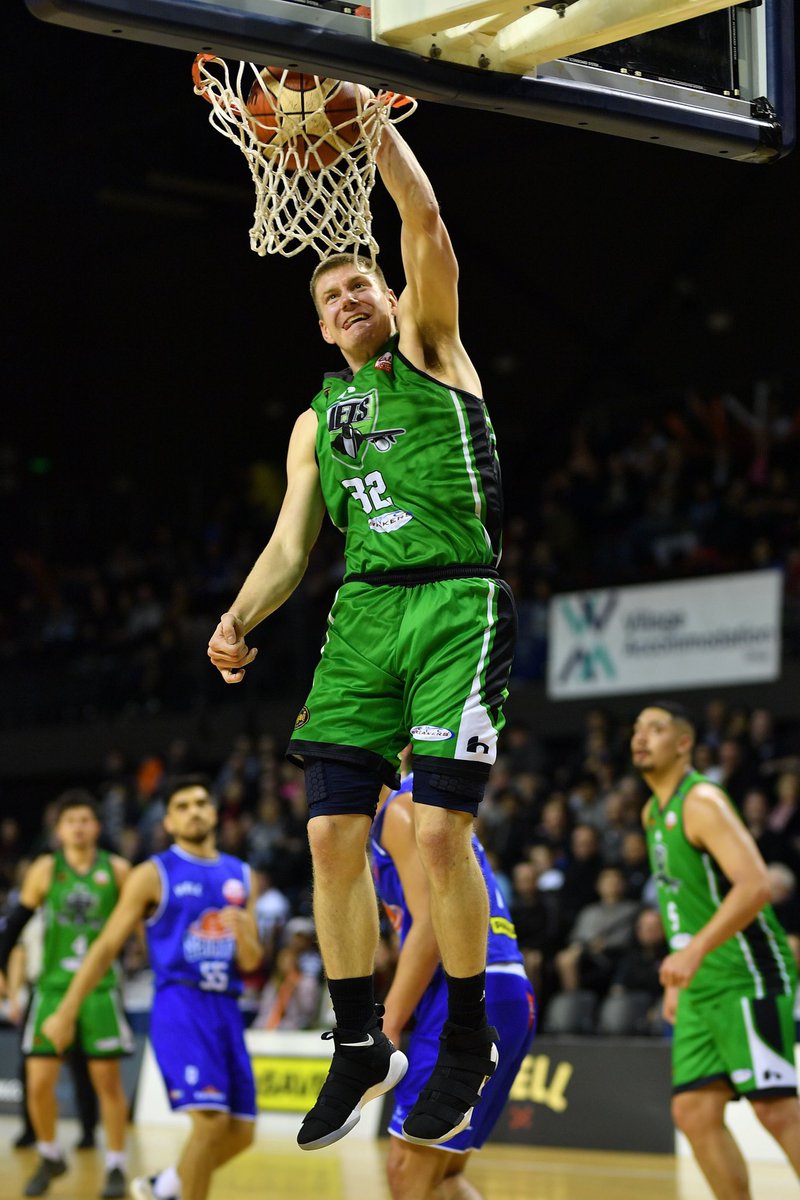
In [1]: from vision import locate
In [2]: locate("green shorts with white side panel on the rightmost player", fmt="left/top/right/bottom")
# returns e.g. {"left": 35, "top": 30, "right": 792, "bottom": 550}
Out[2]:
{"left": 672, "top": 991, "right": 798, "bottom": 1099}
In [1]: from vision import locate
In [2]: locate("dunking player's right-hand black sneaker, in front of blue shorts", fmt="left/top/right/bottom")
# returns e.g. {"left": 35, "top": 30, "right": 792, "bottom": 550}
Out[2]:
{"left": 403, "top": 1021, "right": 500, "bottom": 1146}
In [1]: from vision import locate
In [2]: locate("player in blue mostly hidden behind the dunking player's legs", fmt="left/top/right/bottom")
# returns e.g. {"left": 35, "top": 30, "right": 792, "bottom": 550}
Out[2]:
{"left": 372, "top": 775, "right": 535, "bottom": 1200}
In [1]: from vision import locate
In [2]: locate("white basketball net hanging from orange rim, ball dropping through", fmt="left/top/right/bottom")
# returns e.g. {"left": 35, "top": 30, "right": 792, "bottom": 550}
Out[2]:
{"left": 192, "top": 54, "right": 416, "bottom": 265}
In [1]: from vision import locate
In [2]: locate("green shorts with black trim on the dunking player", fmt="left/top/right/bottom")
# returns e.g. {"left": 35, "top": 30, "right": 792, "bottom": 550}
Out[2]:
{"left": 287, "top": 577, "right": 517, "bottom": 787}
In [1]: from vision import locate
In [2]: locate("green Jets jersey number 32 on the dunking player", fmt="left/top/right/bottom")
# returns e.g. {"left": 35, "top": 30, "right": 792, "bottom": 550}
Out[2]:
{"left": 312, "top": 337, "right": 503, "bottom": 574}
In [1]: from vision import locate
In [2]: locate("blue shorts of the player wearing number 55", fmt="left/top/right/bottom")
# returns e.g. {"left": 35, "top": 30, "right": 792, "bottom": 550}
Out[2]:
{"left": 150, "top": 984, "right": 255, "bottom": 1121}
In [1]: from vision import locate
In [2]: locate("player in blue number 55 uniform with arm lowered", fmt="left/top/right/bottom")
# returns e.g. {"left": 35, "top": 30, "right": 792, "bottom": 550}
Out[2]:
{"left": 46, "top": 776, "right": 261, "bottom": 1200}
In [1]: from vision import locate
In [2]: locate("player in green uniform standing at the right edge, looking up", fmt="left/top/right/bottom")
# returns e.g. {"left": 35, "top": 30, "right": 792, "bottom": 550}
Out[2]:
{"left": 631, "top": 701, "right": 800, "bottom": 1200}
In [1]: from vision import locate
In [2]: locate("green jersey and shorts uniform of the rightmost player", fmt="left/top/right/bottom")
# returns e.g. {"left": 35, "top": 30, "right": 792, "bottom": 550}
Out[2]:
{"left": 645, "top": 772, "right": 798, "bottom": 1097}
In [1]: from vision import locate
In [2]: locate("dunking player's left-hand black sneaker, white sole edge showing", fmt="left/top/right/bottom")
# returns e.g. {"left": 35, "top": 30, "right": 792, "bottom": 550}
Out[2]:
{"left": 297, "top": 1004, "right": 408, "bottom": 1150}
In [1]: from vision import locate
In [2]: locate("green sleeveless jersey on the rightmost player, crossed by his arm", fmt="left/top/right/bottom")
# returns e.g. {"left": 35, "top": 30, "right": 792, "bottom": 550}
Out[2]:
{"left": 645, "top": 772, "right": 795, "bottom": 998}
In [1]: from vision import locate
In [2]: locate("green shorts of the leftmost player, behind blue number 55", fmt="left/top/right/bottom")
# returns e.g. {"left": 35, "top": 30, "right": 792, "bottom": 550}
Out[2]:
{"left": 23, "top": 988, "right": 133, "bottom": 1058}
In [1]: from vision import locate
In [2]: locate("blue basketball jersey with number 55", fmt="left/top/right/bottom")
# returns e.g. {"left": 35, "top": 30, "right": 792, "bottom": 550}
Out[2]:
{"left": 146, "top": 846, "right": 251, "bottom": 996}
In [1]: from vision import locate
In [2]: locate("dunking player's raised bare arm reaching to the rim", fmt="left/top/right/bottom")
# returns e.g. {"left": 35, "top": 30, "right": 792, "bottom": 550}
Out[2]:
{"left": 375, "top": 126, "right": 481, "bottom": 396}
